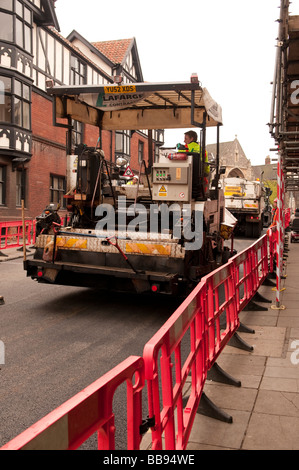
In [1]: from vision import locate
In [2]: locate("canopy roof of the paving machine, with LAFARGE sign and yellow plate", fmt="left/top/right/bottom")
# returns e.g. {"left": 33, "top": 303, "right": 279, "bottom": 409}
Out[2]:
{"left": 47, "top": 77, "right": 222, "bottom": 130}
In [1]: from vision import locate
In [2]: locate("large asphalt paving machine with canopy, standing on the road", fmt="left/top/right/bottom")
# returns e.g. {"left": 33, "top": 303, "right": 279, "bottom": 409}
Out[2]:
{"left": 24, "top": 77, "right": 234, "bottom": 296}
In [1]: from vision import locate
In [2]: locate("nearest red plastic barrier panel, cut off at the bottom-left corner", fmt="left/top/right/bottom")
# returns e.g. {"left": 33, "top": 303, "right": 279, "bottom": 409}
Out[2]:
{"left": 0, "top": 356, "right": 144, "bottom": 450}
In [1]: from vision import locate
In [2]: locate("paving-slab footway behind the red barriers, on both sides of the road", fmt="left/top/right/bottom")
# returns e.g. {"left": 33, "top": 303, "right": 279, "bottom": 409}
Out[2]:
{"left": 0, "top": 243, "right": 299, "bottom": 450}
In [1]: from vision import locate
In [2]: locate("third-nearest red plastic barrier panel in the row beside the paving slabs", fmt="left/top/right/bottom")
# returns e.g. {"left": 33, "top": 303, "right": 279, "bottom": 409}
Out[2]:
{"left": 202, "top": 262, "right": 240, "bottom": 369}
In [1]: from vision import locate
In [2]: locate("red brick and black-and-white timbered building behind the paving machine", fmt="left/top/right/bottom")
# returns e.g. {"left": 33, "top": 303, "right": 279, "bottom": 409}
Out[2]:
{"left": 0, "top": 0, "right": 163, "bottom": 221}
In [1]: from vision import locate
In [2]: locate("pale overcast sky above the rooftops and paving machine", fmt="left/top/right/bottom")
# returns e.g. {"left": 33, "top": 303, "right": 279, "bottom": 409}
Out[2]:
{"left": 56, "top": 0, "right": 299, "bottom": 165}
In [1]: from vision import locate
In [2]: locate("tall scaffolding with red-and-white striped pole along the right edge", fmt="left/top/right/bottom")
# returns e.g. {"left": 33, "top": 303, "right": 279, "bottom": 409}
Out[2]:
{"left": 269, "top": 0, "right": 299, "bottom": 308}
